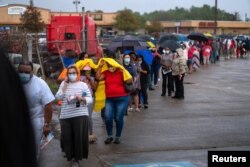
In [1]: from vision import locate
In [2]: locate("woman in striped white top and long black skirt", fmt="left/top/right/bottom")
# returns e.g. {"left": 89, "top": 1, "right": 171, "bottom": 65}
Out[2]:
{"left": 56, "top": 65, "right": 93, "bottom": 166}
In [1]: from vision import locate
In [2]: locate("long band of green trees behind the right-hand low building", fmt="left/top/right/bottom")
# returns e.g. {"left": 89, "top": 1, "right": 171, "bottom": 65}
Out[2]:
{"left": 142, "top": 5, "right": 240, "bottom": 21}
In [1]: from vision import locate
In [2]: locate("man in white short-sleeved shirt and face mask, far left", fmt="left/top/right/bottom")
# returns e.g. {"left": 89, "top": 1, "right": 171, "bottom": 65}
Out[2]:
{"left": 18, "top": 61, "right": 54, "bottom": 159}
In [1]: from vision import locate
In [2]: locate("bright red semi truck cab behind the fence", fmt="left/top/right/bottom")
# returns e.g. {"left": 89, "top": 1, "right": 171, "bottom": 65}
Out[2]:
{"left": 47, "top": 15, "right": 102, "bottom": 57}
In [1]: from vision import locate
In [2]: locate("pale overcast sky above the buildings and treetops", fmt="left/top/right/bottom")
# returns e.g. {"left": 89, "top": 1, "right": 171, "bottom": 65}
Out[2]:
{"left": 0, "top": 0, "right": 250, "bottom": 20}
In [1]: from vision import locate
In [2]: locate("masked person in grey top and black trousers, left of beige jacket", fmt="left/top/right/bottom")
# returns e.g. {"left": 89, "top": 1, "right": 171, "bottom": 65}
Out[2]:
{"left": 161, "top": 48, "right": 174, "bottom": 96}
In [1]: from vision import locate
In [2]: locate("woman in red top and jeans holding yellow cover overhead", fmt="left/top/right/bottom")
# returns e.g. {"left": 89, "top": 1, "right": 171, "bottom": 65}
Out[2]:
{"left": 96, "top": 58, "right": 132, "bottom": 144}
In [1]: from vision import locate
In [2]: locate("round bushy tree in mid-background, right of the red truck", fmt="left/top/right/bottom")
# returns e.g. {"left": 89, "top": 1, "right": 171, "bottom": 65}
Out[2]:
{"left": 114, "top": 9, "right": 140, "bottom": 32}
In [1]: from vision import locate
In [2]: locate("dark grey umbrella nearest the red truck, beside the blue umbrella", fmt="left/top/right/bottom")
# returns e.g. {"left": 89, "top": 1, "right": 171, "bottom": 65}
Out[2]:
{"left": 107, "top": 35, "right": 149, "bottom": 51}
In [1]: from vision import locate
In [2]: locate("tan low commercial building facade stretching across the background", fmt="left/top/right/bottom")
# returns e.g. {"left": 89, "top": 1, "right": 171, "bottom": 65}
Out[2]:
{"left": 0, "top": 4, "right": 250, "bottom": 35}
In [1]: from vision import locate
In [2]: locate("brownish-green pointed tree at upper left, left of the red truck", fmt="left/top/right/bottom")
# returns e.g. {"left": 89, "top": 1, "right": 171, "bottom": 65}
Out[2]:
{"left": 20, "top": 0, "right": 45, "bottom": 33}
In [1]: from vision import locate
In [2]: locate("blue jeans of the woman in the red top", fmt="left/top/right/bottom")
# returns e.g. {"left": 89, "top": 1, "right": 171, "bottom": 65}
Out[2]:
{"left": 104, "top": 96, "right": 129, "bottom": 137}
